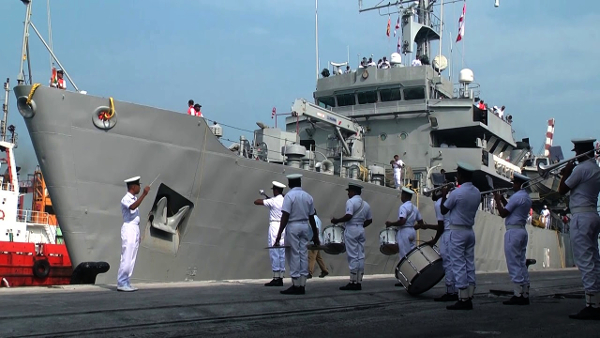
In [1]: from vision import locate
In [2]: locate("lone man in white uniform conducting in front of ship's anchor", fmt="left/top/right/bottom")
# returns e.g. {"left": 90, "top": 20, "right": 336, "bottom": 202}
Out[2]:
{"left": 117, "top": 176, "right": 150, "bottom": 292}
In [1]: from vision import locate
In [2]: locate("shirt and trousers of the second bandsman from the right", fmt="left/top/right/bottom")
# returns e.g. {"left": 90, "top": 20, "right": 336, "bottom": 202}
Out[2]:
{"left": 504, "top": 190, "right": 531, "bottom": 298}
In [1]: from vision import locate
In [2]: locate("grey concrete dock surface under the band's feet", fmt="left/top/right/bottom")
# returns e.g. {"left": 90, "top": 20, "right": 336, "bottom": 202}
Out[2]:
{"left": 0, "top": 269, "right": 600, "bottom": 338}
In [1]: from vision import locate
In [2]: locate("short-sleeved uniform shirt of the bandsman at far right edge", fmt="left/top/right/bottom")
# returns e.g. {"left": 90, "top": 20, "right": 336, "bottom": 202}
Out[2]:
{"left": 565, "top": 160, "right": 600, "bottom": 209}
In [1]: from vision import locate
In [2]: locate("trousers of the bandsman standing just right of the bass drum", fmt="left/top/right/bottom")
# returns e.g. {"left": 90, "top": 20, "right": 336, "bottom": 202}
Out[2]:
{"left": 449, "top": 229, "right": 475, "bottom": 289}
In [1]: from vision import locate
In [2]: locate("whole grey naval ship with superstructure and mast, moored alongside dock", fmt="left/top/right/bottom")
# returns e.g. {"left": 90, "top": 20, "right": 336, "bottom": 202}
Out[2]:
{"left": 9, "top": 0, "right": 572, "bottom": 283}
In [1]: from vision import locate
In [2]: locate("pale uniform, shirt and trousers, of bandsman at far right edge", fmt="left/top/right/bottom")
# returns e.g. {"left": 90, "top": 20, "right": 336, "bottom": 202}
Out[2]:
{"left": 565, "top": 160, "right": 600, "bottom": 300}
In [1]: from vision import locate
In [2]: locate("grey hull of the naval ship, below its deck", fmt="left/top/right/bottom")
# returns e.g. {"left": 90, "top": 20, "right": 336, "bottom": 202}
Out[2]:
{"left": 14, "top": 86, "right": 572, "bottom": 283}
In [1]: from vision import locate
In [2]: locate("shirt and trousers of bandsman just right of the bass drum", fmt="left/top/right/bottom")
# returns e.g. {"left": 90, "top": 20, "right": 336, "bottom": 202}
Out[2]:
{"left": 444, "top": 182, "right": 481, "bottom": 299}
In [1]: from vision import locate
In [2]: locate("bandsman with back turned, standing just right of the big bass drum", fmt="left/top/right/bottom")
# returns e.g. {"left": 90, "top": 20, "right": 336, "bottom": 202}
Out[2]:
{"left": 441, "top": 162, "right": 481, "bottom": 310}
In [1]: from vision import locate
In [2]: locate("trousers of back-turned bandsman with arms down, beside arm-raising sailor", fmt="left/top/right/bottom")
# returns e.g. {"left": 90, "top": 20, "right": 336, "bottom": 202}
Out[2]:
{"left": 285, "top": 222, "right": 311, "bottom": 278}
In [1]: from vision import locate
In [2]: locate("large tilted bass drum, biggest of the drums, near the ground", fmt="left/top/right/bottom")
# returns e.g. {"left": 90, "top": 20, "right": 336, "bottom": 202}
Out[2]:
{"left": 396, "top": 244, "right": 444, "bottom": 295}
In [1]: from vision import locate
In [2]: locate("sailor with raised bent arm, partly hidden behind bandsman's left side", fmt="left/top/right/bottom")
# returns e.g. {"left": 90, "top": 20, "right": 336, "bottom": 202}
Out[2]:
{"left": 254, "top": 181, "right": 285, "bottom": 286}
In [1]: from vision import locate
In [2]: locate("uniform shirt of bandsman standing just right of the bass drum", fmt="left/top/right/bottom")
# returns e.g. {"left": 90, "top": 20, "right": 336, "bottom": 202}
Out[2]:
{"left": 444, "top": 182, "right": 481, "bottom": 227}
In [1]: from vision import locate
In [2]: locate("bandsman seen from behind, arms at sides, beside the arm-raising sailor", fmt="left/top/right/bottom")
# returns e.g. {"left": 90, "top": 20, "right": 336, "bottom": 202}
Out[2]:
{"left": 275, "top": 174, "right": 321, "bottom": 295}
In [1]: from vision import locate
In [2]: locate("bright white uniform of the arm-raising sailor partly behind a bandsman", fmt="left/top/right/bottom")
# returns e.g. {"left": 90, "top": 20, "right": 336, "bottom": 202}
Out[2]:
{"left": 263, "top": 194, "right": 285, "bottom": 278}
